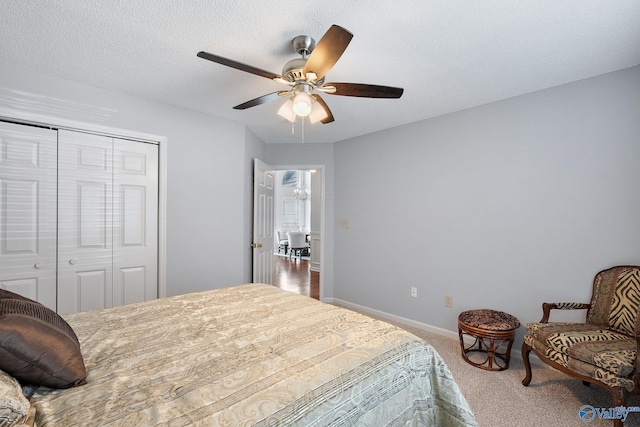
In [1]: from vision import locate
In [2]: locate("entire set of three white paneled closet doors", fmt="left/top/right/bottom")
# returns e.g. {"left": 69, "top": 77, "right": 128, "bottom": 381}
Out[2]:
{"left": 0, "top": 122, "right": 158, "bottom": 314}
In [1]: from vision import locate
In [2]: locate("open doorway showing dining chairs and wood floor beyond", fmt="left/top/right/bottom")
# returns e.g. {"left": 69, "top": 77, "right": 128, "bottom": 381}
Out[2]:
{"left": 272, "top": 166, "right": 323, "bottom": 299}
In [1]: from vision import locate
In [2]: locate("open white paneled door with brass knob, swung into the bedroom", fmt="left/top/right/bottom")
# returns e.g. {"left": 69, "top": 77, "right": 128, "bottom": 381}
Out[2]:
{"left": 252, "top": 159, "right": 274, "bottom": 285}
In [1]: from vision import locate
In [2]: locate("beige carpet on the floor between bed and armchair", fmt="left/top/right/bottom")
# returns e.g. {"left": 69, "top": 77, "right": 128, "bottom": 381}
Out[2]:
{"left": 344, "top": 313, "right": 640, "bottom": 427}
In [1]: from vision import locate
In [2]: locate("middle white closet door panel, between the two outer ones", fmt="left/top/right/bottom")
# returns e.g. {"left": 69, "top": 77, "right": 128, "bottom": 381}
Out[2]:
{"left": 58, "top": 130, "right": 113, "bottom": 314}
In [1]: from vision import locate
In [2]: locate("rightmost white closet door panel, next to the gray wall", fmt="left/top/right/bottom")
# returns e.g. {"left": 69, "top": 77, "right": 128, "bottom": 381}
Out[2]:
{"left": 113, "top": 139, "right": 158, "bottom": 306}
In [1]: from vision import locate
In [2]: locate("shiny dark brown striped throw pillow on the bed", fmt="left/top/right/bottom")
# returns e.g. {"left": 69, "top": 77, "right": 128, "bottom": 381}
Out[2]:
{"left": 0, "top": 289, "right": 87, "bottom": 388}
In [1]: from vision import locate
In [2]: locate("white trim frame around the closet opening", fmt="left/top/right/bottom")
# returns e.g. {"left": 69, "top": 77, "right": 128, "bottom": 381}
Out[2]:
{"left": 0, "top": 115, "right": 167, "bottom": 298}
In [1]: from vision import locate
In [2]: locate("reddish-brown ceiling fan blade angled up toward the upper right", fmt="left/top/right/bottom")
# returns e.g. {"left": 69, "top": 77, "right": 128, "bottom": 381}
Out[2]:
{"left": 303, "top": 25, "right": 353, "bottom": 80}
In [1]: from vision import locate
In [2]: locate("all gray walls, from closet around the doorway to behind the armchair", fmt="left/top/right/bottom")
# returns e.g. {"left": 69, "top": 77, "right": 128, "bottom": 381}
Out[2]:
{"left": 0, "top": 61, "right": 640, "bottom": 348}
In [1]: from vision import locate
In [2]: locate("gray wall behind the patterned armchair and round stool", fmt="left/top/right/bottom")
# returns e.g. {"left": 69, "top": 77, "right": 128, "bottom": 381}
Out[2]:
{"left": 334, "top": 67, "right": 640, "bottom": 344}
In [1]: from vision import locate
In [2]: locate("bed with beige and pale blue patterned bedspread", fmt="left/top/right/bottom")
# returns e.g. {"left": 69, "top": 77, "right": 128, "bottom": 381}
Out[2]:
{"left": 2, "top": 284, "right": 477, "bottom": 427}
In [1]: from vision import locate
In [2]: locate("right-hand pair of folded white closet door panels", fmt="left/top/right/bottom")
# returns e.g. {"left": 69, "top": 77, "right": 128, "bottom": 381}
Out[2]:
{"left": 57, "top": 130, "right": 158, "bottom": 314}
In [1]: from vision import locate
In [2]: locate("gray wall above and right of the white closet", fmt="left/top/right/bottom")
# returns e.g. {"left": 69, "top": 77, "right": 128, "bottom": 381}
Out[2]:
{"left": 0, "top": 66, "right": 255, "bottom": 295}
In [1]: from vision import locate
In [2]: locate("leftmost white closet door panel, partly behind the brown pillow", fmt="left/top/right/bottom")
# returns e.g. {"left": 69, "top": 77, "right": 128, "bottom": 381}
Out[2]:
{"left": 0, "top": 122, "right": 57, "bottom": 310}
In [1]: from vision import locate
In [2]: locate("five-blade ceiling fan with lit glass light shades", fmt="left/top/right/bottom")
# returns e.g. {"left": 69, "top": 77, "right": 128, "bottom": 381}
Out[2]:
{"left": 198, "top": 25, "right": 404, "bottom": 124}
